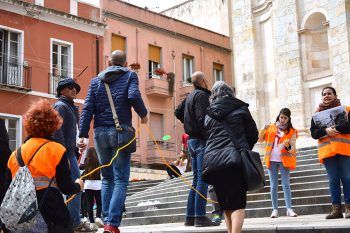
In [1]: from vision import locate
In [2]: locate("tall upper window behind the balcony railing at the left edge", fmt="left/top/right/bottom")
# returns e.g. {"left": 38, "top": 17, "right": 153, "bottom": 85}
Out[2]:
{"left": 0, "top": 28, "right": 22, "bottom": 86}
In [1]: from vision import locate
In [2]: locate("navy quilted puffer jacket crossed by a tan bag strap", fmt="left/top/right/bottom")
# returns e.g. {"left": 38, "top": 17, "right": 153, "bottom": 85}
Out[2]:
{"left": 79, "top": 66, "right": 147, "bottom": 138}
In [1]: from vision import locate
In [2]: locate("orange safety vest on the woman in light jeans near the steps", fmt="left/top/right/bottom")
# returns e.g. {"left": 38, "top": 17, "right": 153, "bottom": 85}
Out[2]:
{"left": 264, "top": 124, "right": 298, "bottom": 170}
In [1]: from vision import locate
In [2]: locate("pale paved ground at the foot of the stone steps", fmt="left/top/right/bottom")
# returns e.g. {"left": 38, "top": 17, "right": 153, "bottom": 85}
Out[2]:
{"left": 98, "top": 214, "right": 350, "bottom": 233}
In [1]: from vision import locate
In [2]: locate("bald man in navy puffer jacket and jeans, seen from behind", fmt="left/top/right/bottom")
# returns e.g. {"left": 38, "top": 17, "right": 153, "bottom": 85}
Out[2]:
{"left": 79, "top": 50, "right": 148, "bottom": 233}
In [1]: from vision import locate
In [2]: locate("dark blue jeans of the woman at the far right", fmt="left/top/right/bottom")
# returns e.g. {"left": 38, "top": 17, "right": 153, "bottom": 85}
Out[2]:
{"left": 323, "top": 154, "right": 350, "bottom": 205}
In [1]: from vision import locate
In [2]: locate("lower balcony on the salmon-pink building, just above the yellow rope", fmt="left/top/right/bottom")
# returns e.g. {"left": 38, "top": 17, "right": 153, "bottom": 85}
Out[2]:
{"left": 147, "top": 141, "right": 176, "bottom": 165}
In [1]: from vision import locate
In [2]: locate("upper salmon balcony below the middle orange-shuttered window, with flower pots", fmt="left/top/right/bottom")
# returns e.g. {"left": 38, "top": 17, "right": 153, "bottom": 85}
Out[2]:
{"left": 145, "top": 76, "right": 172, "bottom": 97}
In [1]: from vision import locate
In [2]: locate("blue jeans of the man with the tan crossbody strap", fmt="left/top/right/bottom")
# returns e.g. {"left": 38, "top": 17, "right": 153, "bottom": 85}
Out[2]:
{"left": 94, "top": 126, "right": 131, "bottom": 227}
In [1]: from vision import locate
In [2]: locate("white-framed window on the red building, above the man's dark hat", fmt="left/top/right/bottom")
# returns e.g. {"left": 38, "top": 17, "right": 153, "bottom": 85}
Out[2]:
{"left": 50, "top": 40, "right": 73, "bottom": 94}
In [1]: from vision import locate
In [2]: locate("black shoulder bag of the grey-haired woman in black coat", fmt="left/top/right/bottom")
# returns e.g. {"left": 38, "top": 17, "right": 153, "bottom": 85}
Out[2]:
{"left": 222, "top": 120, "right": 266, "bottom": 192}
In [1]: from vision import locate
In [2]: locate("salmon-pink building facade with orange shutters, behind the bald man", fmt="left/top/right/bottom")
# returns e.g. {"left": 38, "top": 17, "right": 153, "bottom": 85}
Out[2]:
{"left": 101, "top": 0, "right": 232, "bottom": 167}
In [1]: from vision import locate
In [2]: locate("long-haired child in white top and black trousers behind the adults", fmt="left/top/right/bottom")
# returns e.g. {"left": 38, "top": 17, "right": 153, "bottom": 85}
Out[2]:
{"left": 80, "top": 147, "right": 103, "bottom": 230}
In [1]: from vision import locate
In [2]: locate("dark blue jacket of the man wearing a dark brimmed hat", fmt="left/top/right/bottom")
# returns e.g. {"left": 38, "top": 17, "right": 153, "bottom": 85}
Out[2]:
{"left": 52, "top": 95, "right": 79, "bottom": 155}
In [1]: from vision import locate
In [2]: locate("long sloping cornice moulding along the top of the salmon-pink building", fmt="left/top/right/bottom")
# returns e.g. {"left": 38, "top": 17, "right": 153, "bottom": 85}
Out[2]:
{"left": 103, "top": 10, "right": 232, "bottom": 53}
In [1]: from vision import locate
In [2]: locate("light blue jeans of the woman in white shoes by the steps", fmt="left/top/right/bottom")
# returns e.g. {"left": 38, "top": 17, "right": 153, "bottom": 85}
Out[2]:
{"left": 267, "top": 161, "right": 292, "bottom": 210}
